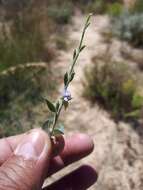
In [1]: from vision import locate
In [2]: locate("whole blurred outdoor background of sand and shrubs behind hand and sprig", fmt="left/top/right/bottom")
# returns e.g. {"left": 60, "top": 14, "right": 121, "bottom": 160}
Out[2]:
{"left": 0, "top": 0, "right": 143, "bottom": 190}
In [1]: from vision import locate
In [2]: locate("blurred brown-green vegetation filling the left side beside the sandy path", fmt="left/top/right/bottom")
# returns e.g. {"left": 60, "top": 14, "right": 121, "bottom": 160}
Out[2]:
{"left": 0, "top": 0, "right": 72, "bottom": 136}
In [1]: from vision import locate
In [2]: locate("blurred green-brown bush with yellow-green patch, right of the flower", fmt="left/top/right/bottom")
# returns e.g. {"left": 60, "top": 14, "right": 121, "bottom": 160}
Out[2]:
{"left": 84, "top": 58, "right": 143, "bottom": 119}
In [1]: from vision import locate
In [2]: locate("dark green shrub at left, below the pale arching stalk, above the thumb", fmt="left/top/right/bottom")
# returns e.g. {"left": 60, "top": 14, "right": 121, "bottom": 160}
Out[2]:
{"left": 0, "top": 64, "right": 56, "bottom": 137}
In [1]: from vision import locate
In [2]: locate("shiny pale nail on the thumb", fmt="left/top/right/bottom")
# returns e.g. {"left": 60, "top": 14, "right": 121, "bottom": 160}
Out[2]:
{"left": 14, "top": 129, "right": 48, "bottom": 160}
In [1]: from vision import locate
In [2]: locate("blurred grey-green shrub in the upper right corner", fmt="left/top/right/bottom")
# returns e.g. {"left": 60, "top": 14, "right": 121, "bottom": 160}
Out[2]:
{"left": 112, "top": 13, "right": 143, "bottom": 48}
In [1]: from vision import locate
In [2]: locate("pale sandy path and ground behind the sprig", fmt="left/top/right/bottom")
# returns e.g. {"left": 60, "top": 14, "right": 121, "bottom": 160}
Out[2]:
{"left": 43, "top": 14, "right": 143, "bottom": 190}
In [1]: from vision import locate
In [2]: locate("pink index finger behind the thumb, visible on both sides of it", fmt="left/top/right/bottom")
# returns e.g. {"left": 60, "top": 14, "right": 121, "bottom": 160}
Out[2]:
{"left": 0, "top": 133, "right": 94, "bottom": 176}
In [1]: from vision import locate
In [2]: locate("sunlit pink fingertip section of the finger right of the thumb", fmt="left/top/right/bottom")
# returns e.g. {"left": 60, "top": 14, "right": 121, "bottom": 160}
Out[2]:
{"left": 47, "top": 134, "right": 94, "bottom": 176}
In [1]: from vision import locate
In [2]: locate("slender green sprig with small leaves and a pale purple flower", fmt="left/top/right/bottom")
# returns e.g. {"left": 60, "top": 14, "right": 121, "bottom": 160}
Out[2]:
{"left": 42, "top": 14, "right": 92, "bottom": 137}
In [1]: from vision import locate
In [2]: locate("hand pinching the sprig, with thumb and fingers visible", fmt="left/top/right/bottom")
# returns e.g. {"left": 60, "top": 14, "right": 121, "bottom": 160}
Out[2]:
{"left": 0, "top": 129, "right": 97, "bottom": 190}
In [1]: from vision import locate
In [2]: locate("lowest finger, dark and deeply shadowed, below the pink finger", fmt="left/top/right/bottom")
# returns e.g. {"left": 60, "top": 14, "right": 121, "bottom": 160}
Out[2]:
{"left": 44, "top": 166, "right": 97, "bottom": 190}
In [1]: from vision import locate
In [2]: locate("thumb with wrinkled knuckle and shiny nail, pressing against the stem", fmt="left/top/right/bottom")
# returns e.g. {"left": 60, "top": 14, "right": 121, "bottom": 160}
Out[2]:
{"left": 0, "top": 129, "right": 51, "bottom": 190}
